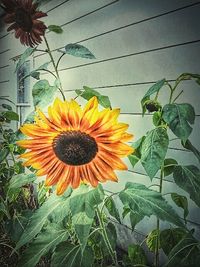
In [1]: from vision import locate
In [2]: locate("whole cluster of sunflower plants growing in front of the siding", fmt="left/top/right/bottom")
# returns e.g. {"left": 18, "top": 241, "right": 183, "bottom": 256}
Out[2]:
{"left": 0, "top": 0, "right": 200, "bottom": 267}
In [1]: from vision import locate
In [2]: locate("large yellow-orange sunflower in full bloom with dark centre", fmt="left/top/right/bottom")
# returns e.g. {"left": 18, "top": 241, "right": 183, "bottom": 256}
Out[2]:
{"left": 17, "top": 97, "right": 133, "bottom": 195}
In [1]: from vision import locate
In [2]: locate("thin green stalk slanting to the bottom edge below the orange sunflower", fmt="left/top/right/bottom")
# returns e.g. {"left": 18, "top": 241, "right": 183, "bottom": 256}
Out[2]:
{"left": 96, "top": 207, "right": 119, "bottom": 267}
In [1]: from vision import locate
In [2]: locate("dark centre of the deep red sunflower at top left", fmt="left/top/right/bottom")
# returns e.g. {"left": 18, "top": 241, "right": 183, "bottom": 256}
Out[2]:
{"left": 15, "top": 8, "right": 33, "bottom": 32}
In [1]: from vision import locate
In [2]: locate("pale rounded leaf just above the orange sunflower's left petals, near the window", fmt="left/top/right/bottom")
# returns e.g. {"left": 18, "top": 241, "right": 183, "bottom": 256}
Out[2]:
{"left": 32, "top": 80, "right": 57, "bottom": 108}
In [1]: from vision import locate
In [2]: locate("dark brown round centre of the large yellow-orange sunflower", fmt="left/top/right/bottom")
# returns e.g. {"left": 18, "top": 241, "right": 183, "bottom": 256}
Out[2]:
{"left": 53, "top": 131, "right": 98, "bottom": 165}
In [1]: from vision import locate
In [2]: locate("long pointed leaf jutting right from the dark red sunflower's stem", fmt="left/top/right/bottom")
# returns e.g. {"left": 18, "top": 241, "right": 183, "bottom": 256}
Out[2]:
{"left": 64, "top": 44, "right": 95, "bottom": 59}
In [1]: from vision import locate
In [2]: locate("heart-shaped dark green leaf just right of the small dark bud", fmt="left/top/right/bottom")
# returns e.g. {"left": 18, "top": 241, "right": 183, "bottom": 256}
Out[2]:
{"left": 162, "top": 103, "right": 195, "bottom": 143}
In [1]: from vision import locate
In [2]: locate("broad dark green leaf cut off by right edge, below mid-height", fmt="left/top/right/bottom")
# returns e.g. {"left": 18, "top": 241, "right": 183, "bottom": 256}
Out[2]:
{"left": 173, "top": 165, "right": 200, "bottom": 207}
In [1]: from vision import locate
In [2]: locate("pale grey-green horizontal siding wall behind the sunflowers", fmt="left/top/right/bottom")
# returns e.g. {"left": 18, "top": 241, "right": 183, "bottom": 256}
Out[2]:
{"left": 0, "top": 0, "right": 200, "bottom": 264}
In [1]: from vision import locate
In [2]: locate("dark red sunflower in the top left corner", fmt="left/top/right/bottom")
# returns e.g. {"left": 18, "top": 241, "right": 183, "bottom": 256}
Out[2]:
{"left": 1, "top": 0, "right": 47, "bottom": 47}
